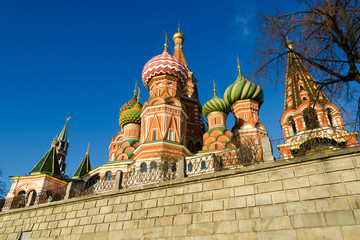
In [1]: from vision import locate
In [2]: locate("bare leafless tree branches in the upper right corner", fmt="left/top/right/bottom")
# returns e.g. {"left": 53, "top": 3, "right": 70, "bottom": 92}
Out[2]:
{"left": 255, "top": 0, "right": 360, "bottom": 106}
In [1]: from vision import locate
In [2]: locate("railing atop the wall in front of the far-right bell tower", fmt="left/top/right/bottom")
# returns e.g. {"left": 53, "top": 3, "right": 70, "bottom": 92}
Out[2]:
{"left": 271, "top": 122, "right": 360, "bottom": 160}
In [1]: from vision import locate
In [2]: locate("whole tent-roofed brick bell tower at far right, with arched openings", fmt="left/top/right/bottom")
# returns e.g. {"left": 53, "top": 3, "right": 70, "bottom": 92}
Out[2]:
{"left": 278, "top": 40, "right": 357, "bottom": 158}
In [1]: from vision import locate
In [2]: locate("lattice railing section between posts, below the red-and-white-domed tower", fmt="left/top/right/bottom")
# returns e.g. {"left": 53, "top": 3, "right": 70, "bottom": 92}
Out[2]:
{"left": 121, "top": 161, "right": 178, "bottom": 188}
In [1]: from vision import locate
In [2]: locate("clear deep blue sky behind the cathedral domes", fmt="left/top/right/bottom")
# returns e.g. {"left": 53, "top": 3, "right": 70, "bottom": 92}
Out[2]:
{"left": 0, "top": 0, "right": 352, "bottom": 191}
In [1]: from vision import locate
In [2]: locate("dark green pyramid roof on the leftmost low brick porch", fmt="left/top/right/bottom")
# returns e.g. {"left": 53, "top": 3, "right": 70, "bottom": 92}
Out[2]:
{"left": 30, "top": 146, "right": 61, "bottom": 176}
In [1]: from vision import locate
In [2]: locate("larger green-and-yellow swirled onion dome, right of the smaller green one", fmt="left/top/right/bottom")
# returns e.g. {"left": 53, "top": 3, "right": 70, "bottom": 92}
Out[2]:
{"left": 224, "top": 67, "right": 264, "bottom": 106}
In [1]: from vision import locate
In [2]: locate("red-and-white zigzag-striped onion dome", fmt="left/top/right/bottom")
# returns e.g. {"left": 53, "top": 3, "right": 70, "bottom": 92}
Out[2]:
{"left": 141, "top": 48, "right": 188, "bottom": 89}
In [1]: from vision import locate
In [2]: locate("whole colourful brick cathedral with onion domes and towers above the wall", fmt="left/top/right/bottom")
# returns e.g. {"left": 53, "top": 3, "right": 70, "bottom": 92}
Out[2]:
{"left": 6, "top": 29, "right": 357, "bottom": 204}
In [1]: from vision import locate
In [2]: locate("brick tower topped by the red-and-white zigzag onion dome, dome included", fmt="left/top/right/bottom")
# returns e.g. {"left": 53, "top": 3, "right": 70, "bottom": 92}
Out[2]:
{"left": 134, "top": 38, "right": 191, "bottom": 159}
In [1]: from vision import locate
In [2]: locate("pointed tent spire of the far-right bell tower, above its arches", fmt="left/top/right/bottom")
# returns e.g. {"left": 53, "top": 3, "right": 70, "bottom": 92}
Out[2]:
{"left": 284, "top": 39, "right": 328, "bottom": 111}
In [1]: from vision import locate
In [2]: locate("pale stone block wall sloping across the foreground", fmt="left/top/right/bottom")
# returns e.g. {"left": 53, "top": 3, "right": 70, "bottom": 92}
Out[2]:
{"left": 0, "top": 148, "right": 360, "bottom": 240}
